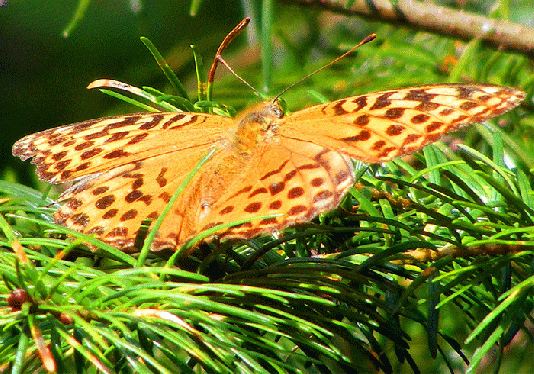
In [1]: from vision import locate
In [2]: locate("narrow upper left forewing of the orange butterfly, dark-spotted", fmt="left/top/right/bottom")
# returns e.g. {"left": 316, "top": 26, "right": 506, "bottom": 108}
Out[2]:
{"left": 13, "top": 113, "right": 233, "bottom": 183}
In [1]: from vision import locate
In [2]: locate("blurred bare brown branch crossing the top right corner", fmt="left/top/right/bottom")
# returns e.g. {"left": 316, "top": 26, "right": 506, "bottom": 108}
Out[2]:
{"left": 284, "top": 0, "right": 534, "bottom": 57}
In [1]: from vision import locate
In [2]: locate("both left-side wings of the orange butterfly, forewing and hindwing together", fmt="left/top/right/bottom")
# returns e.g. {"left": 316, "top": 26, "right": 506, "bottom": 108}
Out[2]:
{"left": 13, "top": 113, "right": 234, "bottom": 250}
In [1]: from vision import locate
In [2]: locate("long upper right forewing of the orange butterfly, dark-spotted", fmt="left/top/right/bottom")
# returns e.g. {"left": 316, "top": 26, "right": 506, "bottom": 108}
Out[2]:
{"left": 280, "top": 84, "right": 525, "bottom": 163}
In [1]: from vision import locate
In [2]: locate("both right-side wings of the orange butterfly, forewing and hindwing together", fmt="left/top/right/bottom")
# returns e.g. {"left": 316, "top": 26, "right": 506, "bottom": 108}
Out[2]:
{"left": 191, "top": 84, "right": 524, "bottom": 245}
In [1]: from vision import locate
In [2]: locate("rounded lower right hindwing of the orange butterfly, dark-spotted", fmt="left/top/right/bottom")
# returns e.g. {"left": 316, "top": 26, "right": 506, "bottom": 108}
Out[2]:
{"left": 186, "top": 138, "right": 354, "bottom": 244}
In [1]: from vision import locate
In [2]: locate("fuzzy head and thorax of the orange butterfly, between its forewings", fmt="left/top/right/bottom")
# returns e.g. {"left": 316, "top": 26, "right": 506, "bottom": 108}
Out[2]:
{"left": 234, "top": 100, "right": 284, "bottom": 155}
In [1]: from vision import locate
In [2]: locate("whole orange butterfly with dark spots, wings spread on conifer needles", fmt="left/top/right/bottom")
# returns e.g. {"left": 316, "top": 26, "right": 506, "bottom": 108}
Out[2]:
{"left": 13, "top": 84, "right": 525, "bottom": 252}
